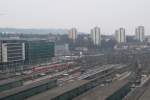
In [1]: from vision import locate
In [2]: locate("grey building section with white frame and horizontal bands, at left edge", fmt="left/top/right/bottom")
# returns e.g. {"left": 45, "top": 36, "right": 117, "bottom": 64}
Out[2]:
{"left": 0, "top": 40, "right": 25, "bottom": 72}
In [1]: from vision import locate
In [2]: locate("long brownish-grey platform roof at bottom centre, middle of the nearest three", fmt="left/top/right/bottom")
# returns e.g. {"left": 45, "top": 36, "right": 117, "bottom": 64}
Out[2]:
{"left": 26, "top": 80, "right": 88, "bottom": 100}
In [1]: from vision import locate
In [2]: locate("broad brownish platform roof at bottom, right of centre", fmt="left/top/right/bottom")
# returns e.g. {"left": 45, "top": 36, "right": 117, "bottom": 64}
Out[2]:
{"left": 73, "top": 78, "right": 128, "bottom": 100}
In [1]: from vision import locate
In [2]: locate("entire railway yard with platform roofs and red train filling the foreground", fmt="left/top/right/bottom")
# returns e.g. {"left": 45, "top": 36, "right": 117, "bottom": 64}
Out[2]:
{"left": 0, "top": 50, "right": 150, "bottom": 100}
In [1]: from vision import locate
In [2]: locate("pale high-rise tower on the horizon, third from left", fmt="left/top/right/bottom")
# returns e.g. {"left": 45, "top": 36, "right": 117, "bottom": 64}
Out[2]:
{"left": 115, "top": 28, "right": 126, "bottom": 43}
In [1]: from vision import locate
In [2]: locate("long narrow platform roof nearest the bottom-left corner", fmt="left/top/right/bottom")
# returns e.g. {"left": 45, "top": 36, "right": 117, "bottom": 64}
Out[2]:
{"left": 0, "top": 79, "right": 54, "bottom": 99}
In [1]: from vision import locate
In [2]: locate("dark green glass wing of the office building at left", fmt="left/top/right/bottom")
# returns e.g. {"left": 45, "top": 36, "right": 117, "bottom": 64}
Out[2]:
{"left": 25, "top": 40, "right": 54, "bottom": 65}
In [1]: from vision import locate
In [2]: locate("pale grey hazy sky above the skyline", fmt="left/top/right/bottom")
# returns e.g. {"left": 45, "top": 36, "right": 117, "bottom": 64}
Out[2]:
{"left": 0, "top": 0, "right": 150, "bottom": 35}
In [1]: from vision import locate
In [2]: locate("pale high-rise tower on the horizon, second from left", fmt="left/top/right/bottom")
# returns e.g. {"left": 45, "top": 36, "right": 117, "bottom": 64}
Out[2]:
{"left": 91, "top": 27, "right": 101, "bottom": 45}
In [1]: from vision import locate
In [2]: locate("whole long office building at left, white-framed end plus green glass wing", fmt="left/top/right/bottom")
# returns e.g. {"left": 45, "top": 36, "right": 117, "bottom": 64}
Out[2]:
{"left": 0, "top": 39, "right": 54, "bottom": 72}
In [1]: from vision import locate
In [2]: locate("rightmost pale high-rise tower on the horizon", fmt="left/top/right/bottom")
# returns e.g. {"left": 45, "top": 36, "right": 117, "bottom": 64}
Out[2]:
{"left": 135, "top": 26, "right": 145, "bottom": 42}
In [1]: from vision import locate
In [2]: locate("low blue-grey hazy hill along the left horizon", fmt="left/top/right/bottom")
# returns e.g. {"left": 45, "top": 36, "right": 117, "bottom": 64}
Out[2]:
{"left": 0, "top": 28, "right": 67, "bottom": 34}
